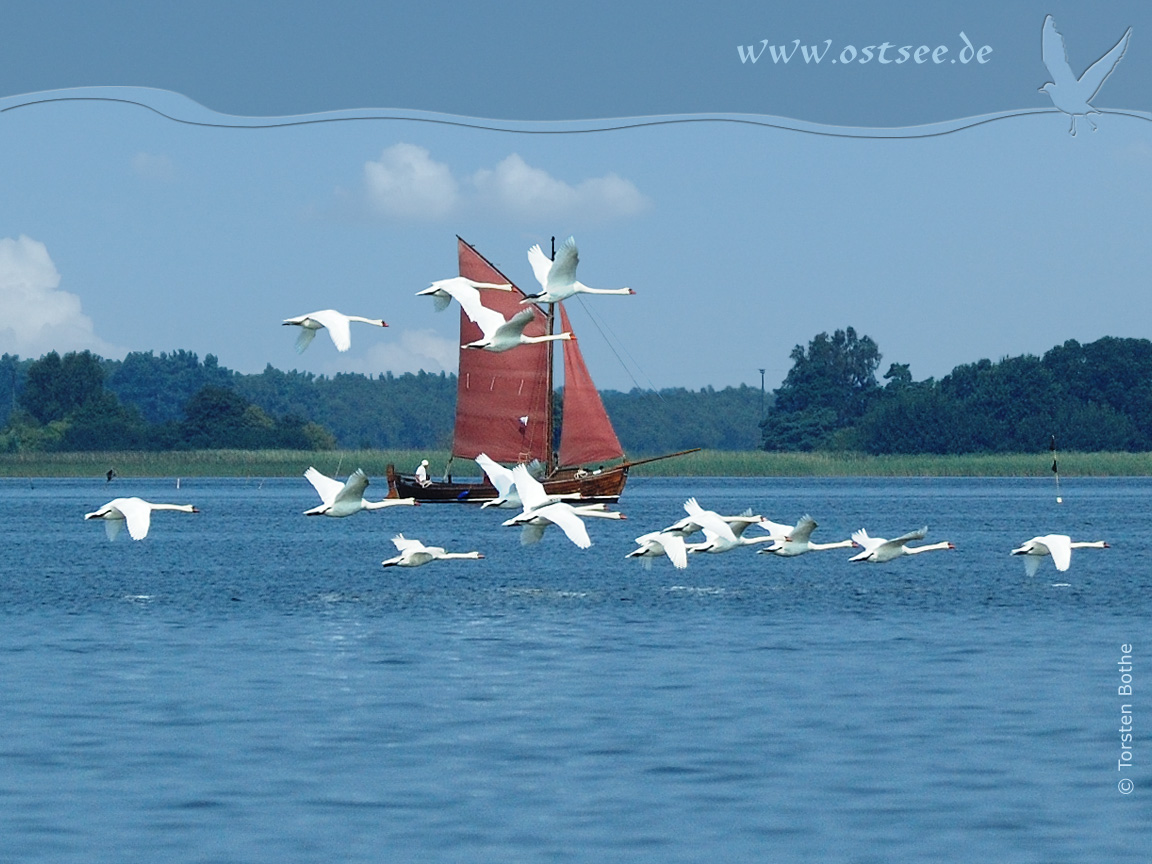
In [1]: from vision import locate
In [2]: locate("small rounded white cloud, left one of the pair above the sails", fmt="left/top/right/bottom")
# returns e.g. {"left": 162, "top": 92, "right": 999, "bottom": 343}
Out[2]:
{"left": 364, "top": 143, "right": 458, "bottom": 219}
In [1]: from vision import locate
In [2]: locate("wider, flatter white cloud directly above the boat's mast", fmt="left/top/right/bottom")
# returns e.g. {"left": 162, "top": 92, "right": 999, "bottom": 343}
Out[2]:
{"left": 472, "top": 153, "right": 649, "bottom": 219}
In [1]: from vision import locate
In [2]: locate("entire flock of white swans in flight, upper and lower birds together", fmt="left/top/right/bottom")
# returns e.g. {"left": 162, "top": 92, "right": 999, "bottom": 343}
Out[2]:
{"left": 84, "top": 237, "right": 1108, "bottom": 576}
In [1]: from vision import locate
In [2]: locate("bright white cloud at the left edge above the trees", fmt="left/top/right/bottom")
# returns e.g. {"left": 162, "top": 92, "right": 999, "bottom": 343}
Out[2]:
{"left": 0, "top": 235, "right": 115, "bottom": 357}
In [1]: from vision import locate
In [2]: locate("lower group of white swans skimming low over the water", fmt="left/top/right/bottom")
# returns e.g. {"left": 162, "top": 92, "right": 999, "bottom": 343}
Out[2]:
{"left": 84, "top": 453, "right": 1108, "bottom": 576}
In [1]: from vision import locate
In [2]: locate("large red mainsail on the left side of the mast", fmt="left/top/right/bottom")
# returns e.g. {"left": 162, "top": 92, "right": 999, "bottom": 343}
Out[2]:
{"left": 452, "top": 237, "right": 550, "bottom": 462}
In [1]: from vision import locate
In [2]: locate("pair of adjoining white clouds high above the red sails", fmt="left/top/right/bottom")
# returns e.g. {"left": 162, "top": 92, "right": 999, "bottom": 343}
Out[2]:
{"left": 364, "top": 143, "right": 651, "bottom": 220}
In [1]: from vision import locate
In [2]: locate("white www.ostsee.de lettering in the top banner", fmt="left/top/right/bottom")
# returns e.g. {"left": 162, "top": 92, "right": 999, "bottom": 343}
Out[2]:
{"left": 736, "top": 30, "right": 992, "bottom": 67}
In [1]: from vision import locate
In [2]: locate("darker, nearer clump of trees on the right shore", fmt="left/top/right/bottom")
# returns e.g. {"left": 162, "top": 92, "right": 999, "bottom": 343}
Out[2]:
{"left": 760, "top": 327, "right": 1152, "bottom": 454}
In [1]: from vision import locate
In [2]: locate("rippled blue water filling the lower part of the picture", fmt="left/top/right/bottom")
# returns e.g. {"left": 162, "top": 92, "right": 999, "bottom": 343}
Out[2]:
{"left": 0, "top": 478, "right": 1152, "bottom": 862}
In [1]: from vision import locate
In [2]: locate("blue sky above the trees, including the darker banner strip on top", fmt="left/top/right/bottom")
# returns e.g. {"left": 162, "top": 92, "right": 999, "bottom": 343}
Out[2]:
{"left": 0, "top": 2, "right": 1152, "bottom": 389}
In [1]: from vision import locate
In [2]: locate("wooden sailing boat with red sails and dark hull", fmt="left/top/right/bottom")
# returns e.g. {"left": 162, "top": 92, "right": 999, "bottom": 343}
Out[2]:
{"left": 387, "top": 236, "right": 679, "bottom": 502}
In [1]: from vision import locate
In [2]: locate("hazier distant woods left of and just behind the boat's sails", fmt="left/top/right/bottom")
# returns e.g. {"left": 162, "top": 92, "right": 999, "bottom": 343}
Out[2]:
{"left": 0, "top": 350, "right": 761, "bottom": 454}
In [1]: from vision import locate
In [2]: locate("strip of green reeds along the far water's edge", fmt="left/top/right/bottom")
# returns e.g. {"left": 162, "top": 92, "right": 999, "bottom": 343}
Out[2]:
{"left": 0, "top": 450, "right": 1152, "bottom": 485}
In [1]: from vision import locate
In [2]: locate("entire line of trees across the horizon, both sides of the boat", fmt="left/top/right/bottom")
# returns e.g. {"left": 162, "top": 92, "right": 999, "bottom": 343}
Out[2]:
{"left": 0, "top": 327, "right": 1152, "bottom": 455}
